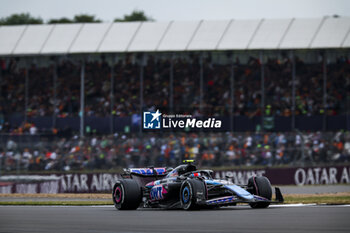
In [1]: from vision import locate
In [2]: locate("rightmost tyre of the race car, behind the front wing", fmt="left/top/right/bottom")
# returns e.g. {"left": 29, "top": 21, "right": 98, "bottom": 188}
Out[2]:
{"left": 248, "top": 176, "right": 272, "bottom": 208}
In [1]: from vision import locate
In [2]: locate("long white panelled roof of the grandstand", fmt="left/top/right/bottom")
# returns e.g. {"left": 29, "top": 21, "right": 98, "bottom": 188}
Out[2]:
{"left": 0, "top": 17, "right": 350, "bottom": 56}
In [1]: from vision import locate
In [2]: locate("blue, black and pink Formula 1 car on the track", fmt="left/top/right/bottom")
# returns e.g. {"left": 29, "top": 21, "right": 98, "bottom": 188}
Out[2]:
{"left": 112, "top": 160, "right": 283, "bottom": 210}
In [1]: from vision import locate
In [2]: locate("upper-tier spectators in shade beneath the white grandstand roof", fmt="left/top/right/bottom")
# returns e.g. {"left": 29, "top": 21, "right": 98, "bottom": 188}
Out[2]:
{"left": 0, "top": 55, "right": 350, "bottom": 121}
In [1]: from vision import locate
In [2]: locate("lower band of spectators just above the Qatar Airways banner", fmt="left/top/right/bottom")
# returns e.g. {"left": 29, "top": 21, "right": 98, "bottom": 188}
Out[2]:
{"left": 0, "top": 132, "right": 350, "bottom": 172}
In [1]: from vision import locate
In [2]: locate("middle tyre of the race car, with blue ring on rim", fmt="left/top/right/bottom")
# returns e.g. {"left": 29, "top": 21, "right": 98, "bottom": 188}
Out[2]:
{"left": 180, "top": 179, "right": 207, "bottom": 210}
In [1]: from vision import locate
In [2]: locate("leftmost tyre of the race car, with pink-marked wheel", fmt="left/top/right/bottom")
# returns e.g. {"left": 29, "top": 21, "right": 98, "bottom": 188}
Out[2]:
{"left": 112, "top": 179, "right": 142, "bottom": 210}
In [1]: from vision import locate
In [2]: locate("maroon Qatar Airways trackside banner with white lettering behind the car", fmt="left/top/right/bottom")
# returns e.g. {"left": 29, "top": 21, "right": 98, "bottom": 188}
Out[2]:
{"left": 0, "top": 166, "right": 350, "bottom": 197}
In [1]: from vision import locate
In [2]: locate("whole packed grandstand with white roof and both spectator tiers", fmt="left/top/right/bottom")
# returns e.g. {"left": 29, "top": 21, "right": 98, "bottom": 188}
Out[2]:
{"left": 0, "top": 17, "right": 350, "bottom": 170}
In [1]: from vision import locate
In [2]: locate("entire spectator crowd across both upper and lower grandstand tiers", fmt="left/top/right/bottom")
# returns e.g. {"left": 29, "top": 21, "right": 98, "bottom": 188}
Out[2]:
{"left": 0, "top": 54, "right": 350, "bottom": 172}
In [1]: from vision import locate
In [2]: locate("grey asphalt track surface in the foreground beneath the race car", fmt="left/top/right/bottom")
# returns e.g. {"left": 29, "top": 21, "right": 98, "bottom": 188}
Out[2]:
{"left": 0, "top": 205, "right": 350, "bottom": 233}
